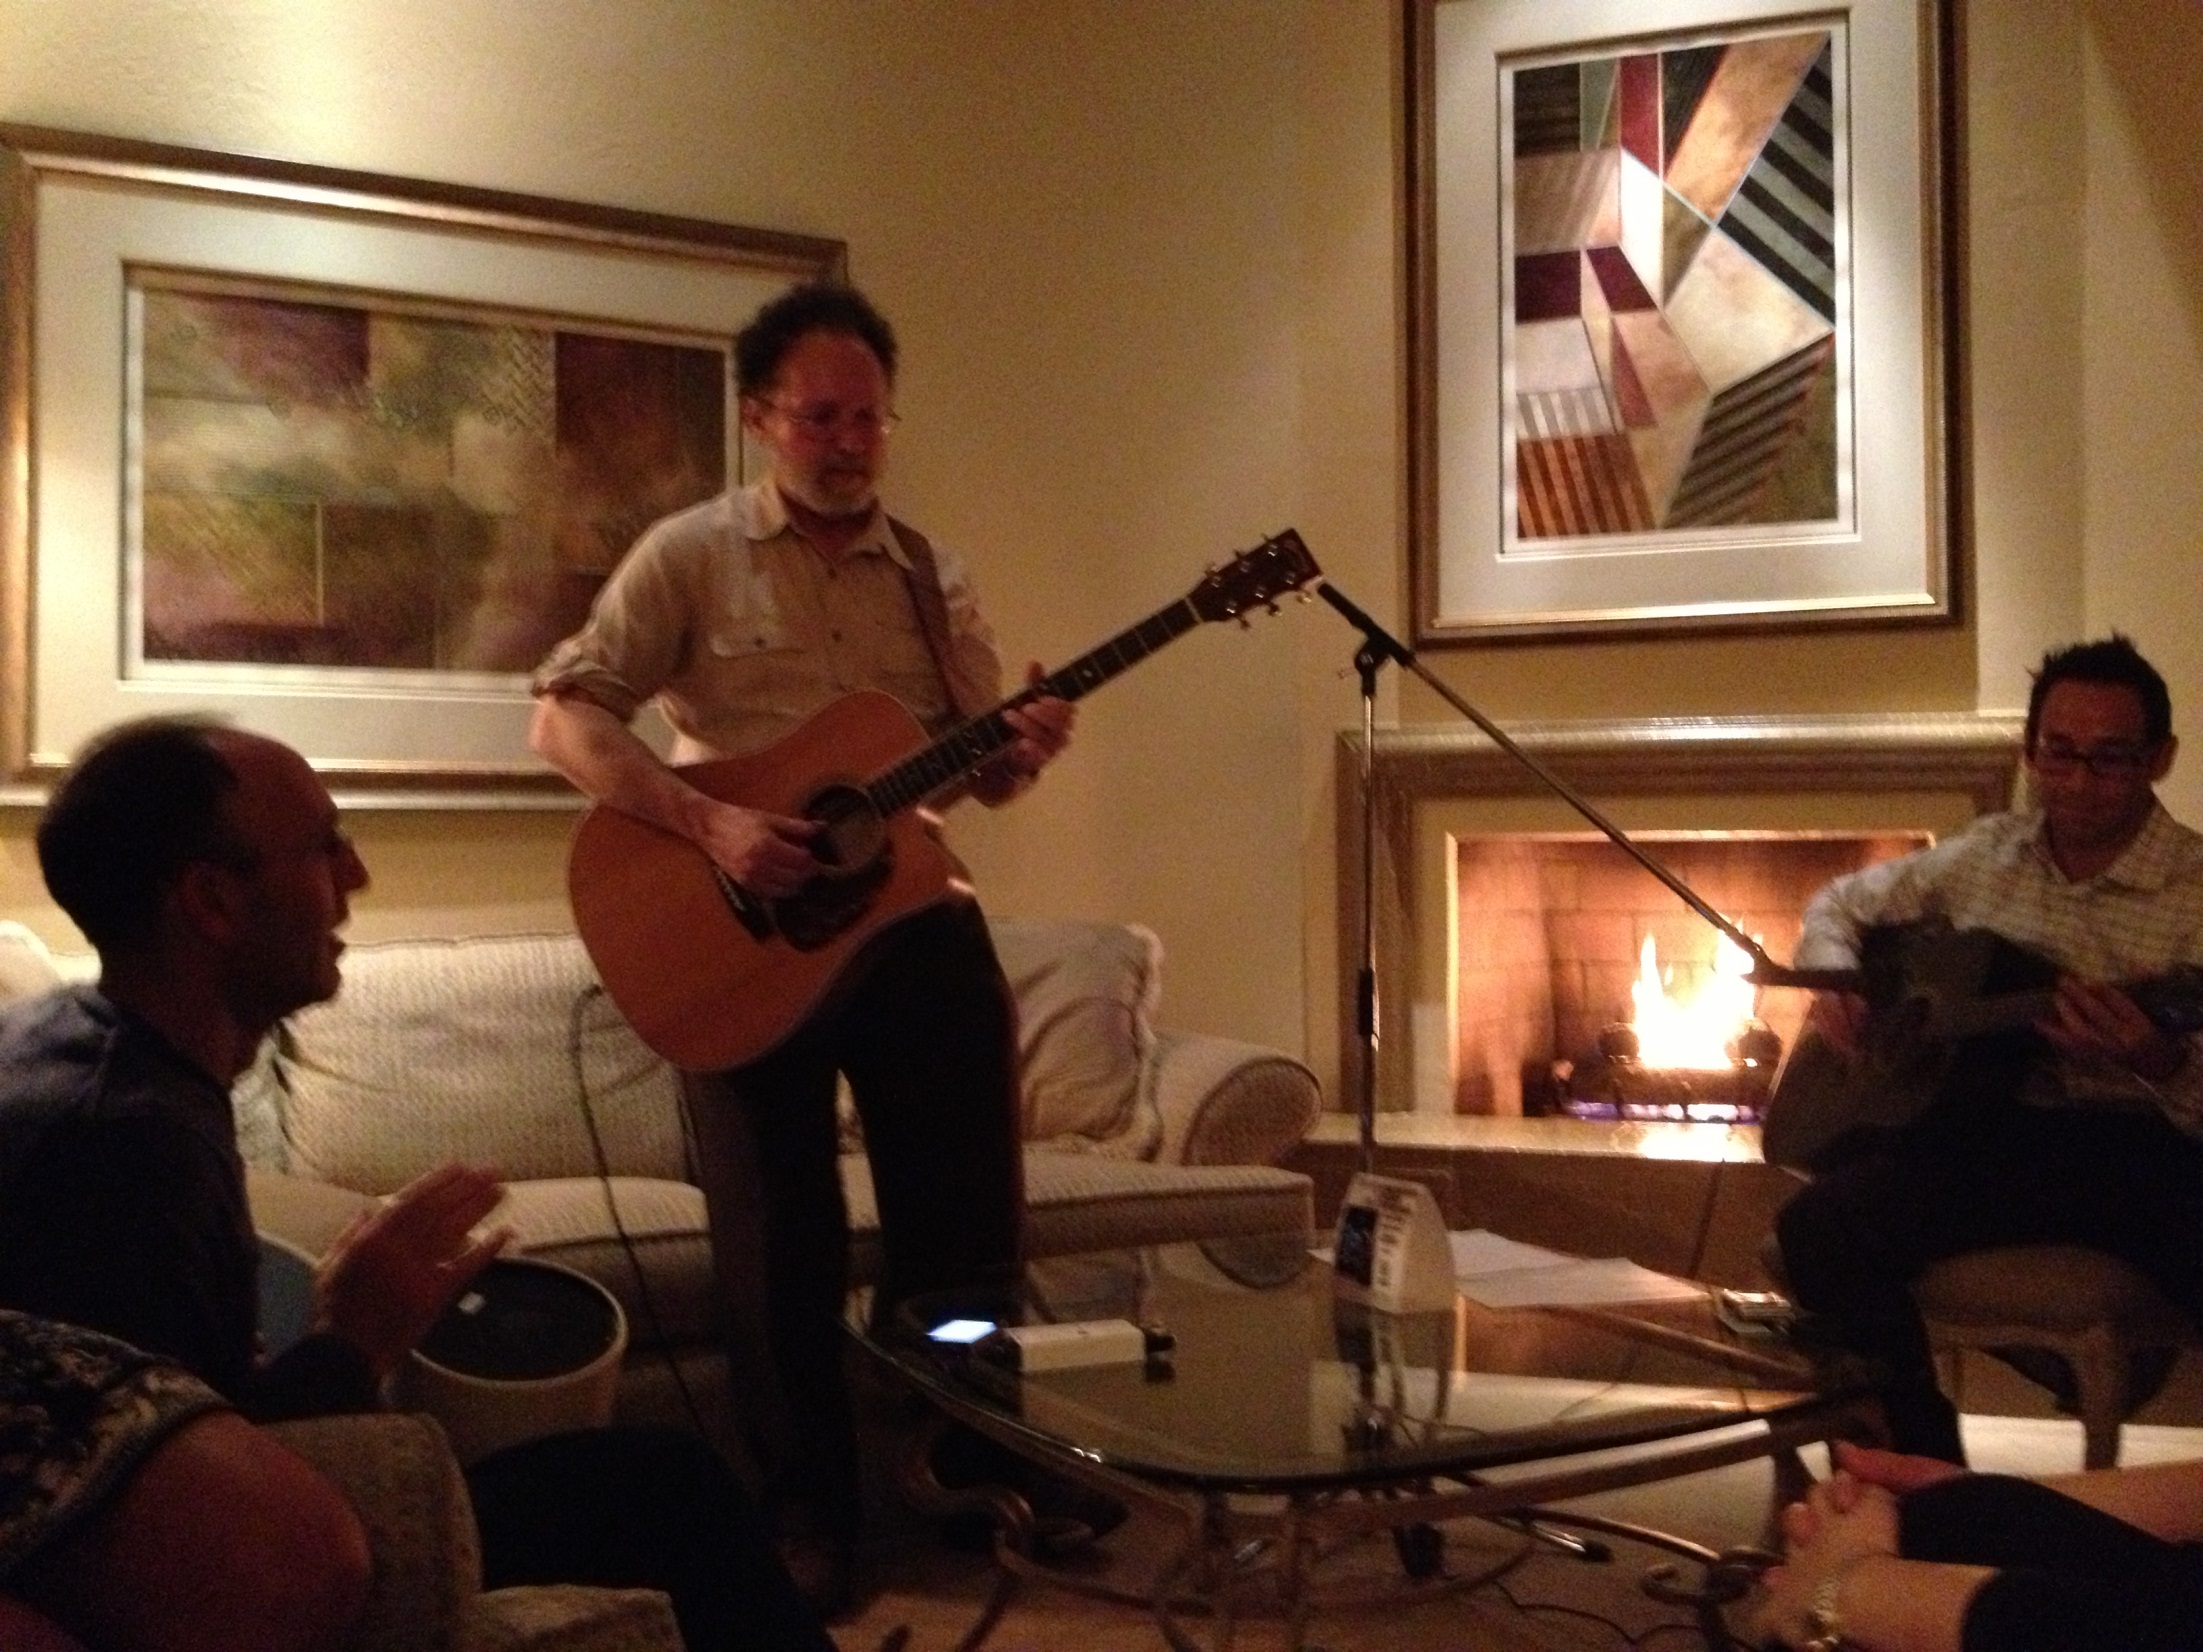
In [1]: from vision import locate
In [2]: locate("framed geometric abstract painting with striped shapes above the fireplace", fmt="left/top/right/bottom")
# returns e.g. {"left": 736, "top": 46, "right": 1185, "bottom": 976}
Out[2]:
{"left": 1406, "top": 0, "right": 1963, "bottom": 643}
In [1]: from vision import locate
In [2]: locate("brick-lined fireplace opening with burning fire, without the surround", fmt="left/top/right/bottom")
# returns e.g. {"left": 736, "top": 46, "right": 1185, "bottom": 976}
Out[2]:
{"left": 1454, "top": 830, "right": 1930, "bottom": 1123}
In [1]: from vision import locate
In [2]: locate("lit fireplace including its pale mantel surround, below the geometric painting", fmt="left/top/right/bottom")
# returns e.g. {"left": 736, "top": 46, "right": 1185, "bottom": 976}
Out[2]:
{"left": 1337, "top": 716, "right": 2020, "bottom": 1121}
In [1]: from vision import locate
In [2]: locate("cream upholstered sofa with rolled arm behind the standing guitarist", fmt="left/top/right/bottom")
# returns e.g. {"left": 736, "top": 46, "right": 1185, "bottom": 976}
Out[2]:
{"left": 0, "top": 921, "right": 1322, "bottom": 1434}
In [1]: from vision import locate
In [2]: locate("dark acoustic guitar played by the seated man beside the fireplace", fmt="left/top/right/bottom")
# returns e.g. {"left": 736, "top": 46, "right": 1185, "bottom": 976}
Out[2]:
{"left": 1760, "top": 919, "right": 2203, "bottom": 1170}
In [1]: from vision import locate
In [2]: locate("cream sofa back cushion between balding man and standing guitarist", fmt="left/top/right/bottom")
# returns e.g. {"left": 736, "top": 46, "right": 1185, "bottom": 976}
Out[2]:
{"left": 278, "top": 934, "right": 687, "bottom": 1194}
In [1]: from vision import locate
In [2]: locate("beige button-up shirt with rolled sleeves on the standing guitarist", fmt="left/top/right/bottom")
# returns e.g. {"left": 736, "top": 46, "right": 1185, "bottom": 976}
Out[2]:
{"left": 533, "top": 478, "right": 1002, "bottom": 762}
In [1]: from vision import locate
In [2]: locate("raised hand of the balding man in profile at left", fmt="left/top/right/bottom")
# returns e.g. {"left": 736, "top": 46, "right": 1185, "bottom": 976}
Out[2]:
{"left": 313, "top": 1165, "right": 513, "bottom": 1377}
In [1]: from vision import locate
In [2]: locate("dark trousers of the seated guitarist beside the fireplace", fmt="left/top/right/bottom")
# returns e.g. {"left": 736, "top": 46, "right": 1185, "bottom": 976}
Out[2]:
{"left": 1776, "top": 1106, "right": 2203, "bottom": 1460}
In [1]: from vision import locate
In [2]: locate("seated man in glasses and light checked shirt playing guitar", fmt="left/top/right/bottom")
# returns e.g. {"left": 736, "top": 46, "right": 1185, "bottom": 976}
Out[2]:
{"left": 1776, "top": 634, "right": 2203, "bottom": 1463}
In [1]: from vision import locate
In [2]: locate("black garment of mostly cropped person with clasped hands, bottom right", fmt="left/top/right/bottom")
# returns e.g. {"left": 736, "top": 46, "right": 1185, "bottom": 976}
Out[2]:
{"left": 1897, "top": 1474, "right": 2203, "bottom": 1652}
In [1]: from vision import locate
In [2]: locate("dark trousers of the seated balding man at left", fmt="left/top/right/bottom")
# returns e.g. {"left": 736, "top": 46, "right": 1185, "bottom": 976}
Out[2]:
{"left": 467, "top": 1427, "right": 833, "bottom": 1652}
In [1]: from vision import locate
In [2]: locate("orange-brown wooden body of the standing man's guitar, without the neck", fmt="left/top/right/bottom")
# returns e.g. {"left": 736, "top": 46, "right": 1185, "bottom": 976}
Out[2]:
{"left": 566, "top": 689, "right": 967, "bottom": 1073}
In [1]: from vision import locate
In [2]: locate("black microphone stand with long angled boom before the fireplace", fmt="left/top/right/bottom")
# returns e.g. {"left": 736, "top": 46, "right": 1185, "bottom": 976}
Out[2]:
{"left": 1315, "top": 579, "right": 1832, "bottom": 1174}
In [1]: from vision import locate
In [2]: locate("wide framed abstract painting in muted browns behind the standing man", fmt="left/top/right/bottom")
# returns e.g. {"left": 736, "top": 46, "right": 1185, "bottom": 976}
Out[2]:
{"left": 0, "top": 128, "right": 844, "bottom": 800}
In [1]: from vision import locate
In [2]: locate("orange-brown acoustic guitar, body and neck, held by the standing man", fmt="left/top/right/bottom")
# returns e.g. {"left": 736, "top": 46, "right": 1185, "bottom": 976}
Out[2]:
{"left": 566, "top": 529, "right": 1322, "bottom": 1073}
